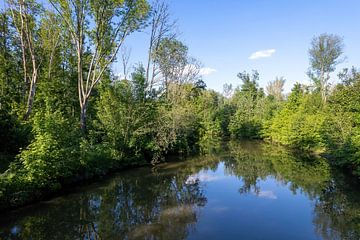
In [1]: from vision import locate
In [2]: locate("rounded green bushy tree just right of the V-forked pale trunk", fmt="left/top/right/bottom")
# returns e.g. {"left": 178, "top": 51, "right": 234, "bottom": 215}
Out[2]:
{"left": 95, "top": 67, "right": 157, "bottom": 160}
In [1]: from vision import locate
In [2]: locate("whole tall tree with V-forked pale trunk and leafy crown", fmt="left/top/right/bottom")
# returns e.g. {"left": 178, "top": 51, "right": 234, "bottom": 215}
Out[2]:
{"left": 50, "top": 0, "right": 150, "bottom": 131}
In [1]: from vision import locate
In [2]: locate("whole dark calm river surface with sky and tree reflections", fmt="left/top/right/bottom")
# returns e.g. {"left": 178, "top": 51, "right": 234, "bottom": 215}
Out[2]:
{"left": 0, "top": 142, "right": 360, "bottom": 240}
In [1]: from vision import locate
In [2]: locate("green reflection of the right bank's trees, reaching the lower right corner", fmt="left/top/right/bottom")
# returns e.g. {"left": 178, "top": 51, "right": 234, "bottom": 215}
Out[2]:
{"left": 224, "top": 141, "right": 360, "bottom": 239}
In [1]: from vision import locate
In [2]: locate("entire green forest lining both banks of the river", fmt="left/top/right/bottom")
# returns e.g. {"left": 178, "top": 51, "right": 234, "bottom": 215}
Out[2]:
{"left": 0, "top": 0, "right": 360, "bottom": 209}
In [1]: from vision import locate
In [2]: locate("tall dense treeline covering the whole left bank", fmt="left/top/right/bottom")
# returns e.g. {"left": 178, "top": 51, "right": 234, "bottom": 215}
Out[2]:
{"left": 0, "top": 0, "right": 218, "bottom": 208}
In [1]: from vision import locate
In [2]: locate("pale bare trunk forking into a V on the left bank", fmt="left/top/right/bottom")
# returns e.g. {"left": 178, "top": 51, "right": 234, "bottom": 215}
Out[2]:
{"left": 50, "top": 0, "right": 141, "bottom": 131}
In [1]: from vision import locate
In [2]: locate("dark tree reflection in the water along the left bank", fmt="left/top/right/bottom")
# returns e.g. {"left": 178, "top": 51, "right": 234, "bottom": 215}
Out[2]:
{"left": 0, "top": 158, "right": 208, "bottom": 239}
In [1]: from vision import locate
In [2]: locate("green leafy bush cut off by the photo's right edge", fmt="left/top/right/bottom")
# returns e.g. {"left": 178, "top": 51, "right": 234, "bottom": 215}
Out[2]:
{"left": 326, "top": 71, "right": 360, "bottom": 176}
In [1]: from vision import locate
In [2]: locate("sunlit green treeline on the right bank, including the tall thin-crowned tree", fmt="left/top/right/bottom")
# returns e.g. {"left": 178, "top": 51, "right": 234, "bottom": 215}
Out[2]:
{"left": 214, "top": 34, "right": 360, "bottom": 177}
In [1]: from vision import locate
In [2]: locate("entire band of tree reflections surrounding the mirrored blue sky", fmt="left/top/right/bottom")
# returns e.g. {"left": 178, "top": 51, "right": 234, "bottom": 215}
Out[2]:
{"left": 0, "top": 141, "right": 360, "bottom": 240}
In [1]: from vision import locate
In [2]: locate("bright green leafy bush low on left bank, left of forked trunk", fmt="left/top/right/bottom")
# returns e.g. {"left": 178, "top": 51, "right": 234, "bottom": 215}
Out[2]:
{"left": 17, "top": 107, "right": 80, "bottom": 188}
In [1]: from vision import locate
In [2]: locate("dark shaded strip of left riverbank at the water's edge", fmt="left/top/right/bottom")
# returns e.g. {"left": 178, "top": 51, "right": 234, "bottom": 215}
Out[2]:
{"left": 0, "top": 142, "right": 197, "bottom": 212}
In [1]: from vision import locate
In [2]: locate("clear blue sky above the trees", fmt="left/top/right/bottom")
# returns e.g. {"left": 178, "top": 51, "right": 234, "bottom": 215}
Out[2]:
{"left": 114, "top": 0, "right": 360, "bottom": 92}
